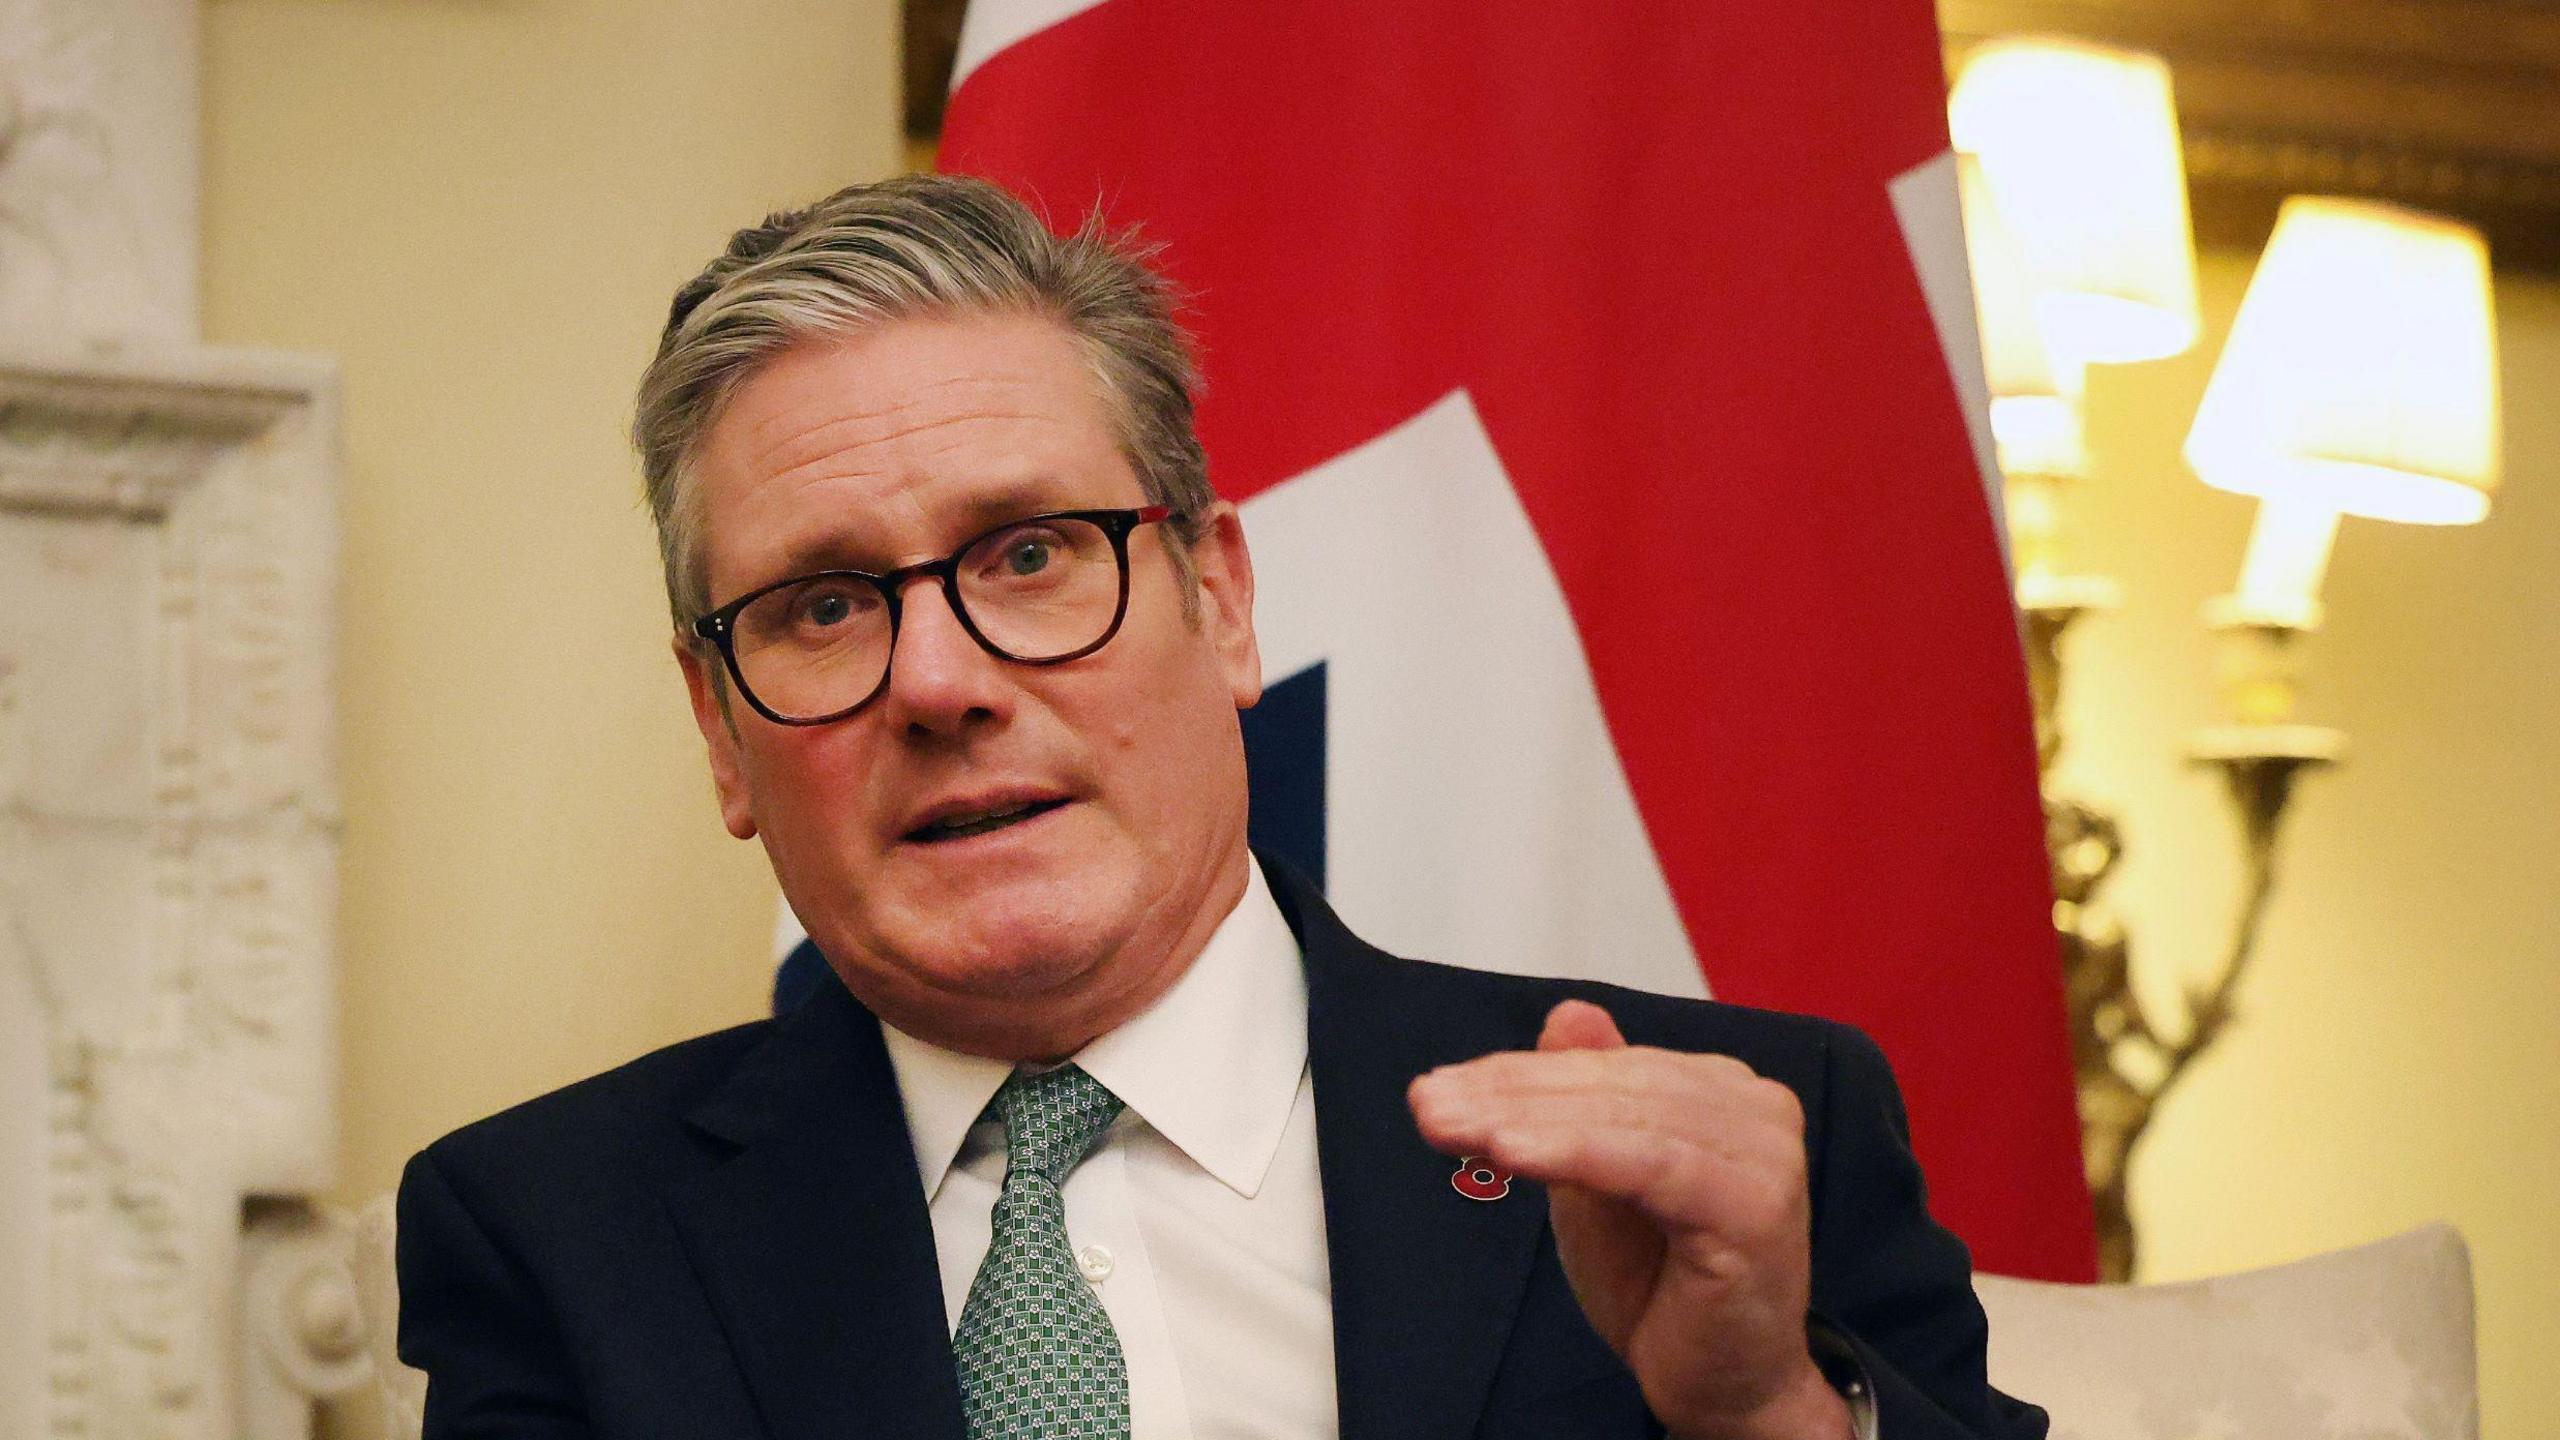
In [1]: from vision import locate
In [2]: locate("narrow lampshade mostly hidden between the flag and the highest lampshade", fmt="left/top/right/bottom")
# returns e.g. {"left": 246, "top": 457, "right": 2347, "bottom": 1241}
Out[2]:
{"left": 1956, "top": 154, "right": 2089, "bottom": 477}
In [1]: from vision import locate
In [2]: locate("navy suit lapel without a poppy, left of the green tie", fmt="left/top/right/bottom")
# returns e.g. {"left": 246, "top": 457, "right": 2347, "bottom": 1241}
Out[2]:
{"left": 666, "top": 979, "right": 963, "bottom": 1440}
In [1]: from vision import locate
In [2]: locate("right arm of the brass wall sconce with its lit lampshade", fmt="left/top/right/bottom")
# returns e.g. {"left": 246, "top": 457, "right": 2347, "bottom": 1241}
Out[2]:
{"left": 2150, "top": 195, "right": 2501, "bottom": 1235}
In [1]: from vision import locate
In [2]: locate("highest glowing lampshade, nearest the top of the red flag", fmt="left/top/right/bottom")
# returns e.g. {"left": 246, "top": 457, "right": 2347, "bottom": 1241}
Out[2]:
{"left": 1948, "top": 38, "right": 2196, "bottom": 361}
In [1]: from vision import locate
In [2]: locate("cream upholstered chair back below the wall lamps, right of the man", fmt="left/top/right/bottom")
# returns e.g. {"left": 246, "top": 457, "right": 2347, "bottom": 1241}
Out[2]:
{"left": 1974, "top": 1225, "right": 2481, "bottom": 1440}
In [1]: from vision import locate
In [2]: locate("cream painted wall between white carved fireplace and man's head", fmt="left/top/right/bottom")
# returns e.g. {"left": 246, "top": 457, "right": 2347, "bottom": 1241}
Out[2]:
{"left": 205, "top": 0, "right": 899, "bottom": 1219}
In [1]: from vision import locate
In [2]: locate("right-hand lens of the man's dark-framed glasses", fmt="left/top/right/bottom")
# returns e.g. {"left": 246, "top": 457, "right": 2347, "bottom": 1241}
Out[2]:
{"left": 960, "top": 518, "right": 1121, "bottom": 661}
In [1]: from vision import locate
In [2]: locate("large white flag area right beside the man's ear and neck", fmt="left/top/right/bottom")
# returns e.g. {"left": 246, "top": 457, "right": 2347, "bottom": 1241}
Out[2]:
{"left": 1244, "top": 389, "right": 1705, "bottom": 997}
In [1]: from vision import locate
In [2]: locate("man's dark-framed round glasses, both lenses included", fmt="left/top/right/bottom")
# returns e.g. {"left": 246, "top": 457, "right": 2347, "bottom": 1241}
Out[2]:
{"left": 694, "top": 505, "right": 1172, "bottom": 725}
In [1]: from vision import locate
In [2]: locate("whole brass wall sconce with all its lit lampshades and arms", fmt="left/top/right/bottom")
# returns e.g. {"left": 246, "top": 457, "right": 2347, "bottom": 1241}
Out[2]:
{"left": 1948, "top": 38, "right": 2499, "bottom": 1279}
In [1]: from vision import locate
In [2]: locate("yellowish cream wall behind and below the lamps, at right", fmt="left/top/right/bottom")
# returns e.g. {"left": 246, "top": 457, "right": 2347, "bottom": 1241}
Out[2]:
{"left": 2066, "top": 254, "right": 2560, "bottom": 1435}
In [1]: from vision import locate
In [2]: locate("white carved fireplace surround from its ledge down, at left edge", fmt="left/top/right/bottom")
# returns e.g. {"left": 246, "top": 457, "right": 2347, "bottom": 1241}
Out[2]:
{"left": 0, "top": 348, "right": 361, "bottom": 1440}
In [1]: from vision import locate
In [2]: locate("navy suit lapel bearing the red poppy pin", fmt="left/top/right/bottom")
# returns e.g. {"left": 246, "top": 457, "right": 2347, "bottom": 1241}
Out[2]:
{"left": 1265, "top": 861, "right": 1546, "bottom": 1440}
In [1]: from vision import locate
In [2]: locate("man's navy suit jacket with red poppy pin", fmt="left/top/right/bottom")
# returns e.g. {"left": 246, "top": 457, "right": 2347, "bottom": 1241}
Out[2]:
{"left": 399, "top": 861, "right": 2045, "bottom": 1440}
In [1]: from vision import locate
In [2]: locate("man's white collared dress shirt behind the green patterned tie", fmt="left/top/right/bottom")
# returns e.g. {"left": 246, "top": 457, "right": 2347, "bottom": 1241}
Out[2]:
{"left": 881, "top": 861, "right": 1339, "bottom": 1440}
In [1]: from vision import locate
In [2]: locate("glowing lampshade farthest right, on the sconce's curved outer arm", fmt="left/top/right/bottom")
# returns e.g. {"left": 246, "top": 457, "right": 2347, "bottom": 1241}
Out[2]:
{"left": 2186, "top": 195, "right": 2499, "bottom": 525}
